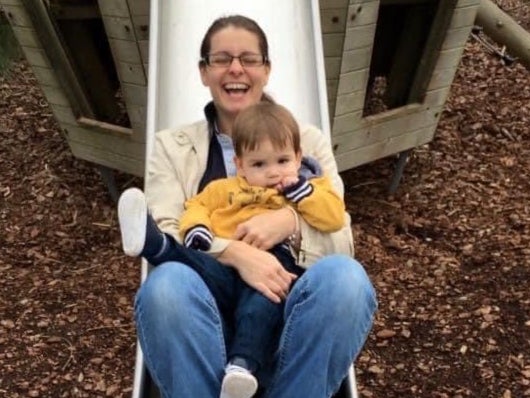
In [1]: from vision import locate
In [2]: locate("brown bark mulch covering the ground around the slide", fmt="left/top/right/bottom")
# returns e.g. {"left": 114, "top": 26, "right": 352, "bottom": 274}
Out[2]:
{"left": 0, "top": 1, "right": 530, "bottom": 398}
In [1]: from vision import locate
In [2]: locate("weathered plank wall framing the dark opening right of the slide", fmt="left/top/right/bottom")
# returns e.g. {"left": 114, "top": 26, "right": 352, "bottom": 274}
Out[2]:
{"left": 325, "top": 0, "right": 480, "bottom": 170}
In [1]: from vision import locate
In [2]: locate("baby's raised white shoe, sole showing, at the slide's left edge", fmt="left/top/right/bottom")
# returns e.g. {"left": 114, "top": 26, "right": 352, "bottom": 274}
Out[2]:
{"left": 118, "top": 188, "right": 147, "bottom": 257}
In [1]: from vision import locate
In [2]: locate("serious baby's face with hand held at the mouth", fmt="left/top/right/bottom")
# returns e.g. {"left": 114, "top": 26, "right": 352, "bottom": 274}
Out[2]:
{"left": 236, "top": 140, "right": 302, "bottom": 188}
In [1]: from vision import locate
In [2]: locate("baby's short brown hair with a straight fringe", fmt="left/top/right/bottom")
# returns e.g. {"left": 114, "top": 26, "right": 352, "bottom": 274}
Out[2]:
{"left": 232, "top": 101, "right": 301, "bottom": 157}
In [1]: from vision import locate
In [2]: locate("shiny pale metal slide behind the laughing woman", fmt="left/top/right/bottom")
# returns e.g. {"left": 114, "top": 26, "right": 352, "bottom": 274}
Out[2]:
{"left": 132, "top": 0, "right": 357, "bottom": 398}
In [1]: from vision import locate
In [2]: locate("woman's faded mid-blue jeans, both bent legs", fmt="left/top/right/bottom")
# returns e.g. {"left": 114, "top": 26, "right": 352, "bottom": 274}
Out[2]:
{"left": 135, "top": 255, "right": 377, "bottom": 398}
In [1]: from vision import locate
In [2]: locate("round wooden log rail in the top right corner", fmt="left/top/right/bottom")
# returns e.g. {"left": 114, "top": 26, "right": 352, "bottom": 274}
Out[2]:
{"left": 475, "top": 0, "right": 530, "bottom": 70}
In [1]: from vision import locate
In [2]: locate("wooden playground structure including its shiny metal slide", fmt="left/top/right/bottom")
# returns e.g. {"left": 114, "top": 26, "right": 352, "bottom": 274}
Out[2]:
{"left": 0, "top": 0, "right": 502, "bottom": 398}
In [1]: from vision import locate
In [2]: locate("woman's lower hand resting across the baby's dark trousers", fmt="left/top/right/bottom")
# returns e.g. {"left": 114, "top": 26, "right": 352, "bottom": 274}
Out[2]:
{"left": 218, "top": 241, "right": 296, "bottom": 303}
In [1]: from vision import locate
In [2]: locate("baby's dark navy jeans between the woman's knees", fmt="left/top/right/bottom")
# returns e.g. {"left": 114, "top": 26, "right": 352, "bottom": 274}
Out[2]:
{"left": 145, "top": 235, "right": 304, "bottom": 373}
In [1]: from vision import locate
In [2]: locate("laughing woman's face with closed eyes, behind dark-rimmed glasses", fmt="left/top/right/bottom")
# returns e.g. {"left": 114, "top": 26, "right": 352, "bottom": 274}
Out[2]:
{"left": 200, "top": 26, "right": 270, "bottom": 123}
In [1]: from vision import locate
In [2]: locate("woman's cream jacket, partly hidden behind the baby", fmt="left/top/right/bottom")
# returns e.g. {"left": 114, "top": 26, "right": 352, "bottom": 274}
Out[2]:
{"left": 145, "top": 120, "right": 354, "bottom": 268}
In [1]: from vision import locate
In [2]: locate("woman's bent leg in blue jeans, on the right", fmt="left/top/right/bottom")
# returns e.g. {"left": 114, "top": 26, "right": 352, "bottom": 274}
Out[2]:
{"left": 265, "top": 255, "right": 377, "bottom": 398}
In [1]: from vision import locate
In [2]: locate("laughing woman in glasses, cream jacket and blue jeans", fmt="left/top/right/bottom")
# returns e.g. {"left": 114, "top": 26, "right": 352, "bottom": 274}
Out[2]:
{"left": 135, "top": 15, "right": 376, "bottom": 398}
